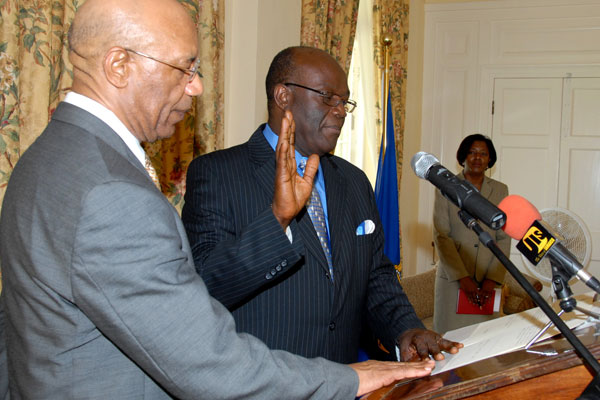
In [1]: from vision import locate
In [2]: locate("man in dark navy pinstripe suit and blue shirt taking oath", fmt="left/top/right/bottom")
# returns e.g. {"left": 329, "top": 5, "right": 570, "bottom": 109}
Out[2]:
{"left": 183, "top": 47, "right": 460, "bottom": 363}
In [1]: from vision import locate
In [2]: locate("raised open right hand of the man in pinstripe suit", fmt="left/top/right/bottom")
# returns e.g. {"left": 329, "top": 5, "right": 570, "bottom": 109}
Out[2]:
{"left": 271, "top": 111, "right": 319, "bottom": 229}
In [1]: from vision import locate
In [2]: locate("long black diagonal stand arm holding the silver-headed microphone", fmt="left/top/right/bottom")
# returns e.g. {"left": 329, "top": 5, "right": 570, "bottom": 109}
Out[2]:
{"left": 458, "top": 210, "right": 600, "bottom": 384}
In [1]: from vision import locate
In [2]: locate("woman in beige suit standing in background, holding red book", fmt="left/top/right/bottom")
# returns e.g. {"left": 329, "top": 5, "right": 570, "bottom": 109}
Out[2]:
{"left": 433, "top": 134, "right": 510, "bottom": 333}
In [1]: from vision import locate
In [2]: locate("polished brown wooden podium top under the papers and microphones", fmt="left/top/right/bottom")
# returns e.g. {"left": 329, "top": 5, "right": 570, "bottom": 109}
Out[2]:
{"left": 362, "top": 326, "right": 600, "bottom": 400}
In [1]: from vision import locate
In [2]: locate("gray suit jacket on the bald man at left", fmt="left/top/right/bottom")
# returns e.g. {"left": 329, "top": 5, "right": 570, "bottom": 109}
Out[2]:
{"left": 0, "top": 103, "right": 358, "bottom": 400}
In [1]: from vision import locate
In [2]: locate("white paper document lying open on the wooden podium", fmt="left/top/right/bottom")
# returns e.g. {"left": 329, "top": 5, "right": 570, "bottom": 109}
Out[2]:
{"left": 432, "top": 293, "right": 600, "bottom": 375}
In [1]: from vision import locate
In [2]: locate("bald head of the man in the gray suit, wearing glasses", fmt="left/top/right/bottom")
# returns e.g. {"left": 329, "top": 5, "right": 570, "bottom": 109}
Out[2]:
{"left": 69, "top": 0, "right": 202, "bottom": 142}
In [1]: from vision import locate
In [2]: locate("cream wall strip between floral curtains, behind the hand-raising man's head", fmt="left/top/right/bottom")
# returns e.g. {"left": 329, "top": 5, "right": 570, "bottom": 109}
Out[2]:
{"left": 224, "top": 0, "right": 302, "bottom": 147}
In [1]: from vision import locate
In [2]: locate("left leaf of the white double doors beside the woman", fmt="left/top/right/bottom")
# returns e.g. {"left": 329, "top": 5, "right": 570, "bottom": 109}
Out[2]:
{"left": 492, "top": 78, "right": 562, "bottom": 208}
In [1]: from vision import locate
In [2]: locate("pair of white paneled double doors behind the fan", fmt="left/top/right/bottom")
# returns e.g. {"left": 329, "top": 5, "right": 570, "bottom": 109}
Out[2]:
{"left": 492, "top": 77, "right": 600, "bottom": 292}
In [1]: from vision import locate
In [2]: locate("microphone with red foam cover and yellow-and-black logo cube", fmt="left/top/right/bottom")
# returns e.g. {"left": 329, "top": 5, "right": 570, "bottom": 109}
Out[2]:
{"left": 498, "top": 194, "right": 600, "bottom": 293}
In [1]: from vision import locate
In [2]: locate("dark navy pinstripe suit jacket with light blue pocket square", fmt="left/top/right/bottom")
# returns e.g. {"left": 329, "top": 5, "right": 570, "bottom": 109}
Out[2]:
{"left": 183, "top": 125, "right": 422, "bottom": 363}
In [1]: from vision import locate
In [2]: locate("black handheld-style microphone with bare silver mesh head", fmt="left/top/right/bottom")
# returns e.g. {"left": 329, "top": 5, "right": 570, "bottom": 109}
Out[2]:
{"left": 410, "top": 151, "right": 506, "bottom": 229}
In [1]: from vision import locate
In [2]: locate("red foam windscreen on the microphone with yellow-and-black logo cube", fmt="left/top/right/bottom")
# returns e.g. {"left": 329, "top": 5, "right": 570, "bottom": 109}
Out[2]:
{"left": 498, "top": 194, "right": 542, "bottom": 240}
